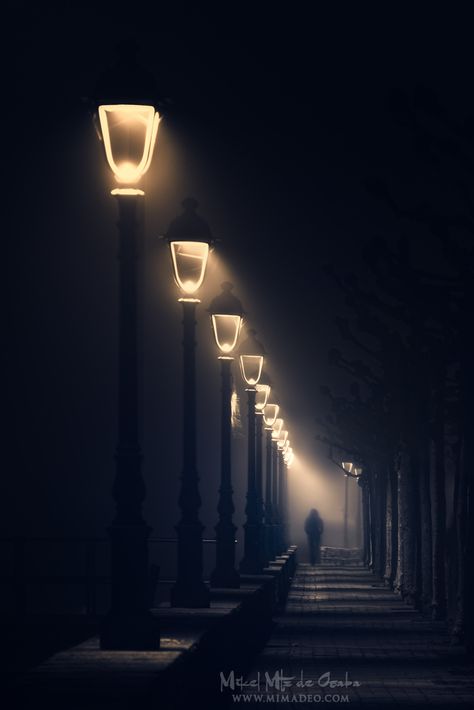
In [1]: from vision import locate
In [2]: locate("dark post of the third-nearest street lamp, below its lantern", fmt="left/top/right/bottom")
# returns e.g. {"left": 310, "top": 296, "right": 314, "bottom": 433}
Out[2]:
{"left": 211, "top": 357, "right": 240, "bottom": 588}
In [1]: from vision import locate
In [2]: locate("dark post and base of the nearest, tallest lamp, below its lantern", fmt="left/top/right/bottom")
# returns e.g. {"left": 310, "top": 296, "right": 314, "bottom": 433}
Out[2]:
{"left": 100, "top": 194, "right": 159, "bottom": 649}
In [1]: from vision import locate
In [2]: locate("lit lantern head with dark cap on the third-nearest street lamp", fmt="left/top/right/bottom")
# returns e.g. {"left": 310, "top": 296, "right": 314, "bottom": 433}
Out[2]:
{"left": 207, "top": 281, "right": 244, "bottom": 358}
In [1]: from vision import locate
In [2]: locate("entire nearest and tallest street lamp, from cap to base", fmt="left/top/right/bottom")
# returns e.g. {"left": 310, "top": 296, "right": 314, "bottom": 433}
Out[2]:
{"left": 94, "top": 52, "right": 160, "bottom": 649}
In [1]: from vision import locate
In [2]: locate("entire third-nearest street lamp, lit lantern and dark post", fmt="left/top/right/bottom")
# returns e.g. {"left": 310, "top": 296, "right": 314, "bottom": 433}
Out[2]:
{"left": 208, "top": 282, "right": 244, "bottom": 588}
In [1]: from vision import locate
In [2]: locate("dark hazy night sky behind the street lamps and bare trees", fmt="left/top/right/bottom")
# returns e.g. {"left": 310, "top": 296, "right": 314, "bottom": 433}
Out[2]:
{"left": 0, "top": 2, "right": 474, "bottom": 556}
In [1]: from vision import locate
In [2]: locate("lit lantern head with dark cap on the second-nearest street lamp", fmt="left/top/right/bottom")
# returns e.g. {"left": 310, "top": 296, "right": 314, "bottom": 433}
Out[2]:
{"left": 166, "top": 197, "right": 212, "bottom": 300}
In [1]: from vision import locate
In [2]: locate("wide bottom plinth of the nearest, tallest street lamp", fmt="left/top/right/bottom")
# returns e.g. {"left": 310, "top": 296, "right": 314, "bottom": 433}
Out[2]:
{"left": 100, "top": 612, "right": 160, "bottom": 651}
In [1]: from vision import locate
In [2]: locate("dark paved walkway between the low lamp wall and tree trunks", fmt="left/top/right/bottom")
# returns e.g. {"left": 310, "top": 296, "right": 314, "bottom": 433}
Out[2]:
{"left": 231, "top": 564, "right": 474, "bottom": 708}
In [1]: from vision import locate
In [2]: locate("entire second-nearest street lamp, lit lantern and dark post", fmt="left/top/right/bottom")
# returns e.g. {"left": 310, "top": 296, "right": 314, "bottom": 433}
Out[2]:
{"left": 166, "top": 198, "right": 212, "bottom": 608}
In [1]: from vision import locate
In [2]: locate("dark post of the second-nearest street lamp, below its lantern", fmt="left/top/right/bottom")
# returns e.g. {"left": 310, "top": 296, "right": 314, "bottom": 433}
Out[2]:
{"left": 171, "top": 298, "right": 210, "bottom": 608}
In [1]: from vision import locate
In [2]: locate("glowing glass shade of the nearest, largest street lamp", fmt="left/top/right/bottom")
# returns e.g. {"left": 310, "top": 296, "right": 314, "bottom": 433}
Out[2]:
{"left": 99, "top": 104, "right": 160, "bottom": 185}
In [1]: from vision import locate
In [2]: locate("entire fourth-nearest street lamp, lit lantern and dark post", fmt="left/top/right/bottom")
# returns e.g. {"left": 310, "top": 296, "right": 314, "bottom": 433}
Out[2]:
{"left": 240, "top": 330, "right": 265, "bottom": 574}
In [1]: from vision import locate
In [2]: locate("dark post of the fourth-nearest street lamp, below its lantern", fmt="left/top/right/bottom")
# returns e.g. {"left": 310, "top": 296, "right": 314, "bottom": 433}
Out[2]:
{"left": 240, "top": 388, "right": 263, "bottom": 574}
